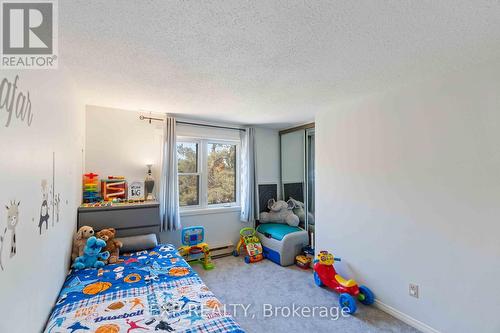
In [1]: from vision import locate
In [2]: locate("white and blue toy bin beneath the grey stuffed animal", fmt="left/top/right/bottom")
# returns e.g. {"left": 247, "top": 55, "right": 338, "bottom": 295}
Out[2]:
{"left": 257, "top": 223, "right": 309, "bottom": 266}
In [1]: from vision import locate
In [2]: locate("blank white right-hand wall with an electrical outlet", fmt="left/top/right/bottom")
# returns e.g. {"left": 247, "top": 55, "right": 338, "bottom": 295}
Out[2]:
{"left": 316, "top": 63, "right": 500, "bottom": 332}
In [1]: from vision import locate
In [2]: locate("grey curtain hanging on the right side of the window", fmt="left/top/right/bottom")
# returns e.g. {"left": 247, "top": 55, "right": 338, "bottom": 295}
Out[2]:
{"left": 240, "top": 128, "right": 255, "bottom": 222}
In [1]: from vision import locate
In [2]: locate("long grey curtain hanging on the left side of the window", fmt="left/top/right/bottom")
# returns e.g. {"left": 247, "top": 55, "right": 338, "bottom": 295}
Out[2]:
{"left": 160, "top": 116, "right": 182, "bottom": 230}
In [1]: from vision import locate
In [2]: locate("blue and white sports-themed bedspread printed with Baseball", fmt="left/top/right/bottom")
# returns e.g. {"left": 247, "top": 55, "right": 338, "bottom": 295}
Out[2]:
{"left": 45, "top": 245, "right": 243, "bottom": 333}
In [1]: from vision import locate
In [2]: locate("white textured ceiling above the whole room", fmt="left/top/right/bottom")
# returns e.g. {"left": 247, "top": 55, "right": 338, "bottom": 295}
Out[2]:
{"left": 59, "top": 0, "right": 500, "bottom": 127}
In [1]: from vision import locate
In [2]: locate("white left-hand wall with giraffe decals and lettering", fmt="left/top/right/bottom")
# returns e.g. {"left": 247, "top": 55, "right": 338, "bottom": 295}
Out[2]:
{"left": 0, "top": 66, "right": 84, "bottom": 332}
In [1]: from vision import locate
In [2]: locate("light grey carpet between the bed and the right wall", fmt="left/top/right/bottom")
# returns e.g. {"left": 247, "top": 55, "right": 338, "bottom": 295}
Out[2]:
{"left": 195, "top": 256, "right": 418, "bottom": 333}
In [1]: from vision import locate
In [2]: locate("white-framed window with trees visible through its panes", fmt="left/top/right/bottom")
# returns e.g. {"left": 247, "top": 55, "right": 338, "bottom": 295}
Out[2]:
{"left": 177, "top": 138, "right": 239, "bottom": 209}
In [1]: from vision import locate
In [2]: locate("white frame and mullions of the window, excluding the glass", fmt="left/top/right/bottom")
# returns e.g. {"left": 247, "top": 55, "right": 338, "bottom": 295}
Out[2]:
{"left": 176, "top": 136, "right": 241, "bottom": 213}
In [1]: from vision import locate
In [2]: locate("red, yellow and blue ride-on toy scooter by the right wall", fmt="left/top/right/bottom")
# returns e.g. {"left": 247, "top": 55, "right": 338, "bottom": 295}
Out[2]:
{"left": 314, "top": 251, "right": 375, "bottom": 314}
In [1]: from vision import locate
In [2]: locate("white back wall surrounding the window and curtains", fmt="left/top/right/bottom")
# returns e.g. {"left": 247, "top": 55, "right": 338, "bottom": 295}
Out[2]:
{"left": 85, "top": 106, "right": 279, "bottom": 246}
